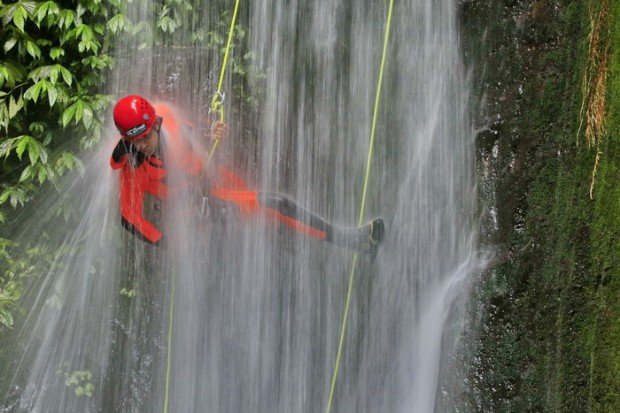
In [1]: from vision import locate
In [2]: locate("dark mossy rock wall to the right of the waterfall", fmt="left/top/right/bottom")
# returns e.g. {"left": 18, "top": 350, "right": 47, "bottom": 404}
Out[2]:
{"left": 460, "top": 0, "right": 620, "bottom": 412}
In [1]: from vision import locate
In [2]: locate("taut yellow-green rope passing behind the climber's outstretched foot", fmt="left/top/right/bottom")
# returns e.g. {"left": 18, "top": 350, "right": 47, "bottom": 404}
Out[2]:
{"left": 325, "top": 0, "right": 394, "bottom": 413}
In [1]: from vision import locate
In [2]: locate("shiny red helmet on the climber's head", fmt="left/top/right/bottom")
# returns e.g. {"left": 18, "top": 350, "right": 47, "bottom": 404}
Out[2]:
{"left": 114, "top": 95, "right": 157, "bottom": 140}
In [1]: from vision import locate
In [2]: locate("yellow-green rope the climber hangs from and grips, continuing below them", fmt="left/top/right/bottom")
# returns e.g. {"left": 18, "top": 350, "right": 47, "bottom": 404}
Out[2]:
{"left": 164, "top": 0, "right": 240, "bottom": 413}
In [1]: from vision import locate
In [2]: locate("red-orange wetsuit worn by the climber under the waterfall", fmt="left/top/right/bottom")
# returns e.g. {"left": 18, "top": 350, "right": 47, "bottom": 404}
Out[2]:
{"left": 110, "top": 103, "right": 334, "bottom": 244}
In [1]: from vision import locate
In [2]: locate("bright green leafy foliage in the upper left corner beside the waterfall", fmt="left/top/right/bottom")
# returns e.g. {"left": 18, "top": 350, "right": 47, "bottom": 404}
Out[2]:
{"left": 0, "top": 0, "right": 123, "bottom": 212}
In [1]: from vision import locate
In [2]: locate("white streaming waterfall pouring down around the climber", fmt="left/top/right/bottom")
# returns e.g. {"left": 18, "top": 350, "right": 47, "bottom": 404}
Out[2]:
{"left": 5, "top": 0, "right": 479, "bottom": 412}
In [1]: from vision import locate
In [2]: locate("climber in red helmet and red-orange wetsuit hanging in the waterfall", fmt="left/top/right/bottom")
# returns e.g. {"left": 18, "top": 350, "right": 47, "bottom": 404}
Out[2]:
{"left": 110, "top": 95, "right": 384, "bottom": 252}
